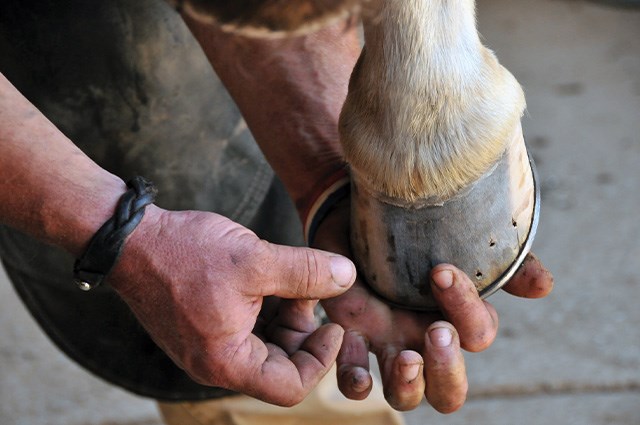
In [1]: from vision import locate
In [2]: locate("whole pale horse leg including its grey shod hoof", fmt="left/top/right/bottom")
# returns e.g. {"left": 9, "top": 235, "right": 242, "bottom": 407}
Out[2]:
{"left": 340, "top": 0, "right": 538, "bottom": 309}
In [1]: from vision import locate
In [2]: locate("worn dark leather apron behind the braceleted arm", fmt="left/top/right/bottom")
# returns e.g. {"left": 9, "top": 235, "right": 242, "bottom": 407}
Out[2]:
{"left": 0, "top": 0, "right": 302, "bottom": 400}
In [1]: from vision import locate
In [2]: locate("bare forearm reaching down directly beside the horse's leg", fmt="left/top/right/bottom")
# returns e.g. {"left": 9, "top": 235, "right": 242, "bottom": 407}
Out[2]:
{"left": 185, "top": 17, "right": 360, "bottom": 219}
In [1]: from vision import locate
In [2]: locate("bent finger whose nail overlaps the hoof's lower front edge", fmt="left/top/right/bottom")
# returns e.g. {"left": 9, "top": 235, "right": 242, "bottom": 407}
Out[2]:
{"left": 431, "top": 264, "right": 498, "bottom": 352}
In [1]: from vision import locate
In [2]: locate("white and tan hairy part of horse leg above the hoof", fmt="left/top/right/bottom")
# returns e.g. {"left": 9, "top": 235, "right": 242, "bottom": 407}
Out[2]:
{"left": 340, "top": 0, "right": 525, "bottom": 201}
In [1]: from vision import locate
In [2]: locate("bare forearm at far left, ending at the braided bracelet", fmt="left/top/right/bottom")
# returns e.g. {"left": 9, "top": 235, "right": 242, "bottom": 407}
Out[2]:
{"left": 0, "top": 74, "right": 126, "bottom": 255}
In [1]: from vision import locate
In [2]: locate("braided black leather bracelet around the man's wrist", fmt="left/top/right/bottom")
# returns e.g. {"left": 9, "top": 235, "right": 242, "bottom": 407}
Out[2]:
{"left": 73, "top": 177, "right": 157, "bottom": 291}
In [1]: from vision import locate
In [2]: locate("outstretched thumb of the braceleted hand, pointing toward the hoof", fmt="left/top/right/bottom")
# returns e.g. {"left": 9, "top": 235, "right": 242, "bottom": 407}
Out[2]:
{"left": 261, "top": 244, "right": 356, "bottom": 299}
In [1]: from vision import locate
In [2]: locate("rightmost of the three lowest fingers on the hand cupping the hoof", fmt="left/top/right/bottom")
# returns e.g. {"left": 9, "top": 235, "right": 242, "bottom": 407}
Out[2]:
{"left": 425, "top": 321, "right": 468, "bottom": 413}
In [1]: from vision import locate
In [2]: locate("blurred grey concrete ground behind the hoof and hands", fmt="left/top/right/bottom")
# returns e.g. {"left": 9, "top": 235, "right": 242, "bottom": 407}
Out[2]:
{"left": 0, "top": 0, "right": 640, "bottom": 425}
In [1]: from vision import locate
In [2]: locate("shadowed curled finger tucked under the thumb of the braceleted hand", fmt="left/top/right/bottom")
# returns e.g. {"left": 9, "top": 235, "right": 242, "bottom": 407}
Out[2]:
{"left": 265, "top": 300, "right": 317, "bottom": 355}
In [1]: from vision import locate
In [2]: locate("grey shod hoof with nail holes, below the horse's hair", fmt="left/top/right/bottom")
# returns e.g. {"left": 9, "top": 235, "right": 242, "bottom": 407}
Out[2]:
{"left": 351, "top": 125, "right": 540, "bottom": 310}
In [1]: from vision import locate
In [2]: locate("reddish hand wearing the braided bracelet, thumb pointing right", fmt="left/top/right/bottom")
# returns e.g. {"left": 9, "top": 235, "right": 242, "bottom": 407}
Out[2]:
{"left": 109, "top": 205, "right": 355, "bottom": 406}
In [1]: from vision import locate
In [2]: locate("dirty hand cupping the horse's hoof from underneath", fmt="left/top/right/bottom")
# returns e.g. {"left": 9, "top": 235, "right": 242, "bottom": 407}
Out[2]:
{"left": 315, "top": 202, "right": 553, "bottom": 413}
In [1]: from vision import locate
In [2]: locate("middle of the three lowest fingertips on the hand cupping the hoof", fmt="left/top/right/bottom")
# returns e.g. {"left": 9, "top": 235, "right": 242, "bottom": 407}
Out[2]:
{"left": 379, "top": 350, "right": 425, "bottom": 411}
